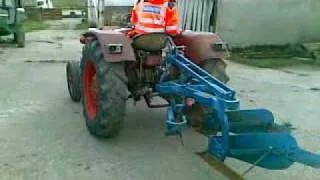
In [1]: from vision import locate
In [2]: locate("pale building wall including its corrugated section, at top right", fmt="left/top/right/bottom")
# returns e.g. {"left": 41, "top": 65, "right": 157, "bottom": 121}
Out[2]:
{"left": 179, "top": 0, "right": 320, "bottom": 46}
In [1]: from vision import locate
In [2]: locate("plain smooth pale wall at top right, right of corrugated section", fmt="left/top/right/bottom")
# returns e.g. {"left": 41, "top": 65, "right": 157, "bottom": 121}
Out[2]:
{"left": 216, "top": 0, "right": 320, "bottom": 46}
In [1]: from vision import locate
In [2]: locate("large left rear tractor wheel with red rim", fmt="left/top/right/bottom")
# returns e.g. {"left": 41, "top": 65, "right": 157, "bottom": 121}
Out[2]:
{"left": 81, "top": 41, "right": 127, "bottom": 138}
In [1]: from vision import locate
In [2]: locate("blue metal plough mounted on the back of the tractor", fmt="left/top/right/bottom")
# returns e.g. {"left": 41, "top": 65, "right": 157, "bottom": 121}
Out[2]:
{"left": 156, "top": 41, "right": 320, "bottom": 174}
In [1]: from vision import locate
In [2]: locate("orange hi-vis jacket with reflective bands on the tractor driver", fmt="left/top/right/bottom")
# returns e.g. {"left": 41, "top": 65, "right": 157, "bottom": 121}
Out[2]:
{"left": 131, "top": 0, "right": 181, "bottom": 35}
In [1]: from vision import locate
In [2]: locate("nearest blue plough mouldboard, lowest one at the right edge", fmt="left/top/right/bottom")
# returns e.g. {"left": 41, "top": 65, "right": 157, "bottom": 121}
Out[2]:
{"left": 209, "top": 132, "right": 320, "bottom": 170}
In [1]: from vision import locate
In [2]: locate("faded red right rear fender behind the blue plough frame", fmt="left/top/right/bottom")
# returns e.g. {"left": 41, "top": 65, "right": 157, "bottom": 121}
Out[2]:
{"left": 174, "top": 31, "right": 226, "bottom": 64}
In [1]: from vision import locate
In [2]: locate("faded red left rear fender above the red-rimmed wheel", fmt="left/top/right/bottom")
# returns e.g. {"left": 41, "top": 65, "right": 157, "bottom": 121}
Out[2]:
{"left": 80, "top": 29, "right": 135, "bottom": 62}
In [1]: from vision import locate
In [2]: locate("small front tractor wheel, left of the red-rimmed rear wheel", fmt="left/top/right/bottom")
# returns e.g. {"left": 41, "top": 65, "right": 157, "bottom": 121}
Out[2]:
{"left": 66, "top": 61, "right": 81, "bottom": 102}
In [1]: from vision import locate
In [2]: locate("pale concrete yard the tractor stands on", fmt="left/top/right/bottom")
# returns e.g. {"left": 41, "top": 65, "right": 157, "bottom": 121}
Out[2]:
{"left": 0, "top": 20, "right": 320, "bottom": 180}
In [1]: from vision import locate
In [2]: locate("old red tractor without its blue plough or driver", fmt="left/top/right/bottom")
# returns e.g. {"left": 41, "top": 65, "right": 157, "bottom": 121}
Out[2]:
{"left": 67, "top": 28, "right": 229, "bottom": 137}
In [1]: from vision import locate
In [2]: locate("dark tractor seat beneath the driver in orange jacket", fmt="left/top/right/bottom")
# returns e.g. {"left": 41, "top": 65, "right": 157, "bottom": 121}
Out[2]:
{"left": 132, "top": 33, "right": 170, "bottom": 52}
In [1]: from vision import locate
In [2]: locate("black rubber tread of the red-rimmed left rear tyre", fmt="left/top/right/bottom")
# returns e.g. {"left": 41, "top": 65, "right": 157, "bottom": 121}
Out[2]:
{"left": 84, "top": 41, "right": 127, "bottom": 138}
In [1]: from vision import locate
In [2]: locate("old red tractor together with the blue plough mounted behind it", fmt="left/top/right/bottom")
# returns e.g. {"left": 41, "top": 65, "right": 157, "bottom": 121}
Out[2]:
{"left": 66, "top": 1, "right": 320, "bottom": 173}
